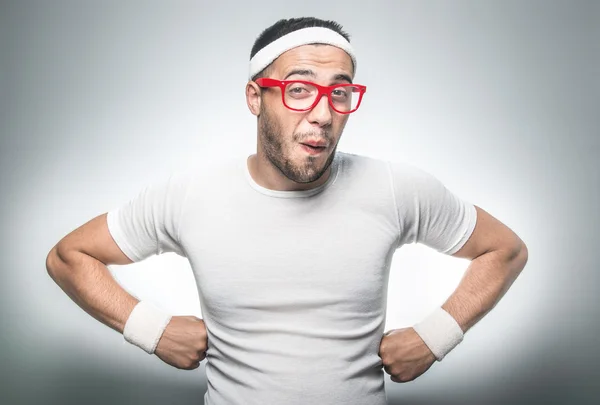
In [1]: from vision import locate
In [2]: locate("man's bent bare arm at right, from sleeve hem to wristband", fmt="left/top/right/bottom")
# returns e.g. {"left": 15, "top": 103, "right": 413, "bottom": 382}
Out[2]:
{"left": 442, "top": 206, "right": 528, "bottom": 332}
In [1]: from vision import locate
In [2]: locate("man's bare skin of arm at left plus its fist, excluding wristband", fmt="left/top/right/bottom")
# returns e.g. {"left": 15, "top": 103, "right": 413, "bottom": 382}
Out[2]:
{"left": 46, "top": 213, "right": 208, "bottom": 370}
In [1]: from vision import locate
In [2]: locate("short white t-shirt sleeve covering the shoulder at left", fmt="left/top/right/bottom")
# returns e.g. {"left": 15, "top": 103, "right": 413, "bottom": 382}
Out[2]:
{"left": 106, "top": 171, "right": 189, "bottom": 262}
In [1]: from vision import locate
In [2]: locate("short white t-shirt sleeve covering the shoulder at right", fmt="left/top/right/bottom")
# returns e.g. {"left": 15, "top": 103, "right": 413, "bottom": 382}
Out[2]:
{"left": 388, "top": 161, "right": 477, "bottom": 255}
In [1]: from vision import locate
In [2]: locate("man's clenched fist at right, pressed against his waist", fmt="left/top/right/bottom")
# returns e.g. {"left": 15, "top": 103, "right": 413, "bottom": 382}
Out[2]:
{"left": 379, "top": 327, "right": 436, "bottom": 383}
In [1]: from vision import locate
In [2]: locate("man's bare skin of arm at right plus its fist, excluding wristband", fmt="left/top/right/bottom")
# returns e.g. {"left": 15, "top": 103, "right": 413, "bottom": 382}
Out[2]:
{"left": 379, "top": 206, "right": 528, "bottom": 383}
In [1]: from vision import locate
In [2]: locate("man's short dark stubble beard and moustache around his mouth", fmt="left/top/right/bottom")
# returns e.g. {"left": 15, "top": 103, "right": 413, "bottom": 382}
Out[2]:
{"left": 259, "top": 109, "right": 337, "bottom": 183}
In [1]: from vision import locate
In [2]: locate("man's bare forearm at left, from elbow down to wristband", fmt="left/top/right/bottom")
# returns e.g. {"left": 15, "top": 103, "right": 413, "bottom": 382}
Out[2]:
{"left": 46, "top": 248, "right": 139, "bottom": 334}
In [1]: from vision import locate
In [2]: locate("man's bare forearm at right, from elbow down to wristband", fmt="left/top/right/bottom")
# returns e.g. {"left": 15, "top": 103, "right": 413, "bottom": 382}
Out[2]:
{"left": 442, "top": 245, "right": 527, "bottom": 332}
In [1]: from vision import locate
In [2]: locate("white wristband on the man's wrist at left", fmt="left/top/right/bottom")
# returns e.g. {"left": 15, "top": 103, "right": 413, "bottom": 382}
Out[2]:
{"left": 123, "top": 301, "right": 171, "bottom": 354}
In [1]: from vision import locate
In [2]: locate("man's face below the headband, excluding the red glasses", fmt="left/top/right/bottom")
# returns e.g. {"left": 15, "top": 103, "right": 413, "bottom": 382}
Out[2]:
{"left": 258, "top": 45, "right": 353, "bottom": 183}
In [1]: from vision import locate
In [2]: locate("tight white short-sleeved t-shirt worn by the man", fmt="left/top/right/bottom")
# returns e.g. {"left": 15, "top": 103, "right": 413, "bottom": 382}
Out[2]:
{"left": 108, "top": 151, "right": 476, "bottom": 405}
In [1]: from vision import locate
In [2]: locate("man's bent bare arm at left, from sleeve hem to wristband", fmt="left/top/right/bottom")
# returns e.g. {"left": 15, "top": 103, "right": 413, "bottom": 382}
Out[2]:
{"left": 46, "top": 213, "right": 139, "bottom": 333}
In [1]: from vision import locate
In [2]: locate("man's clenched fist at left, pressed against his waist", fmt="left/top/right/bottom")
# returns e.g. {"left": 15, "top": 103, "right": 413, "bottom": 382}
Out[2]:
{"left": 154, "top": 316, "right": 208, "bottom": 370}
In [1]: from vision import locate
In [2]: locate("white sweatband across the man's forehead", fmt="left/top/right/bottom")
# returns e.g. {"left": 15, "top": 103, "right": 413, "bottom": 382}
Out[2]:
{"left": 248, "top": 27, "right": 356, "bottom": 80}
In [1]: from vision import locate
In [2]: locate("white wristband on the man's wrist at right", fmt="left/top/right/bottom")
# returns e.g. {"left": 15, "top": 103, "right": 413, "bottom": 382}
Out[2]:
{"left": 413, "top": 307, "right": 464, "bottom": 361}
